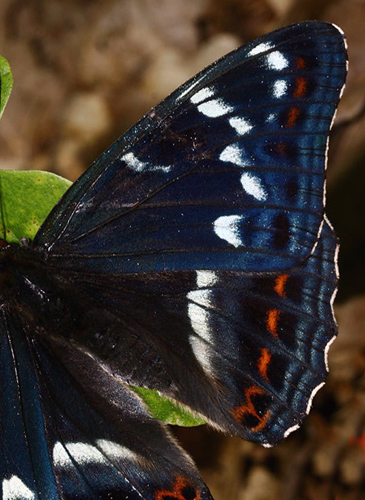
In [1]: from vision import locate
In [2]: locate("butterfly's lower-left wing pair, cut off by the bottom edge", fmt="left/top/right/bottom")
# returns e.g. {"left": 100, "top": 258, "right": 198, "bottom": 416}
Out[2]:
{"left": 0, "top": 310, "right": 211, "bottom": 500}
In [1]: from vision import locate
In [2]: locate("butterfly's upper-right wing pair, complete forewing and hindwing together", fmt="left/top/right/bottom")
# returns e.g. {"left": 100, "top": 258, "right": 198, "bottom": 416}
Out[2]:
{"left": 29, "top": 22, "right": 346, "bottom": 444}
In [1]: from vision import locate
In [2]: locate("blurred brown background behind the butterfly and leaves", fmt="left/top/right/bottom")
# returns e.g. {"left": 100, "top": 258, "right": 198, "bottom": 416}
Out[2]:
{"left": 0, "top": 0, "right": 365, "bottom": 500}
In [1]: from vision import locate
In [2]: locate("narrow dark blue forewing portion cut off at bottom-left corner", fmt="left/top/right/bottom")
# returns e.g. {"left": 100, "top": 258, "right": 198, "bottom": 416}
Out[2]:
{"left": 0, "top": 308, "right": 57, "bottom": 499}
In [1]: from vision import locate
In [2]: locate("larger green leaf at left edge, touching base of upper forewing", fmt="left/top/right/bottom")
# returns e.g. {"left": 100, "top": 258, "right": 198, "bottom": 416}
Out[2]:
{"left": 0, "top": 170, "right": 71, "bottom": 243}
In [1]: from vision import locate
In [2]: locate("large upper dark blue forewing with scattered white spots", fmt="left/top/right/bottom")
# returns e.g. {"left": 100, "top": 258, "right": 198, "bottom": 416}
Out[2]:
{"left": 34, "top": 22, "right": 346, "bottom": 274}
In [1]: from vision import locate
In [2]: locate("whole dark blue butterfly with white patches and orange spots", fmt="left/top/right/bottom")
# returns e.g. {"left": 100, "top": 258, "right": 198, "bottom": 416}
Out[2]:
{"left": 0, "top": 22, "right": 347, "bottom": 500}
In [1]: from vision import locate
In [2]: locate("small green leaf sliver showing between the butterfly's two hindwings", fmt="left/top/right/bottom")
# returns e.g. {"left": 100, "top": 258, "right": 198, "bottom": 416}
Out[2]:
{"left": 130, "top": 386, "right": 205, "bottom": 427}
